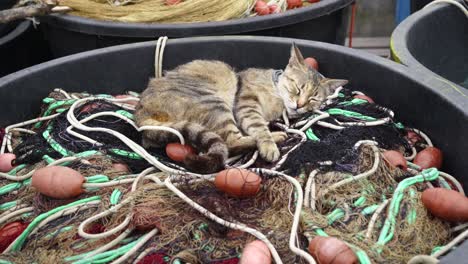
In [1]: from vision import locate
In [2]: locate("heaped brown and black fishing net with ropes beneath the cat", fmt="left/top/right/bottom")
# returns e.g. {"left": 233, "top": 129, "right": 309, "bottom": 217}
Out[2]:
{"left": 0, "top": 85, "right": 463, "bottom": 264}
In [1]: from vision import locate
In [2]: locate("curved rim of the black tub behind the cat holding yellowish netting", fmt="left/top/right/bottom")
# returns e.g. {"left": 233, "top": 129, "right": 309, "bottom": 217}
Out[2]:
{"left": 40, "top": 0, "right": 355, "bottom": 38}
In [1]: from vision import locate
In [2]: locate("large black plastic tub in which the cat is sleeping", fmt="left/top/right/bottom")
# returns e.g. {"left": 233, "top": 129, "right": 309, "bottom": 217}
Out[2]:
{"left": 0, "top": 36, "right": 468, "bottom": 264}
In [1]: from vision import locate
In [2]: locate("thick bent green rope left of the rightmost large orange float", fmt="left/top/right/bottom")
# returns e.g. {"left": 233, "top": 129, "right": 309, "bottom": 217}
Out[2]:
{"left": 377, "top": 168, "right": 439, "bottom": 249}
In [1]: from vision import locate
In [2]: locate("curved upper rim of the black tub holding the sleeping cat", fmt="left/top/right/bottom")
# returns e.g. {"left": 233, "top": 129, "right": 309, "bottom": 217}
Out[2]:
{"left": 0, "top": 36, "right": 468, "bottom": 118}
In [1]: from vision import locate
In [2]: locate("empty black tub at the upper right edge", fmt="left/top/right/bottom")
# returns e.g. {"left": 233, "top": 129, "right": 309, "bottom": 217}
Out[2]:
{"left": 391, "top": 1, "right": 468, "bottom": 92}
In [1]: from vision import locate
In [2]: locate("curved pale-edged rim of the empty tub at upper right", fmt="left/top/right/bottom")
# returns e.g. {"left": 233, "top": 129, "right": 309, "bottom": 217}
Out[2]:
{"left": 390, "top": 3, "right": 468, "bottom": 97}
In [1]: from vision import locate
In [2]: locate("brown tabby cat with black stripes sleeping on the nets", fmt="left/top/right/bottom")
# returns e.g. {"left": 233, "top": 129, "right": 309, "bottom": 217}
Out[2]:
{"left": 135, "top": 44, "right": 347, "bottom": 173}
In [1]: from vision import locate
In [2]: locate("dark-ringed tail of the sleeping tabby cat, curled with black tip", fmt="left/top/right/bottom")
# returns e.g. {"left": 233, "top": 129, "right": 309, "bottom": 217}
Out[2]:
{"left": 171, "top": 122, "right": 228, "bottom": 173}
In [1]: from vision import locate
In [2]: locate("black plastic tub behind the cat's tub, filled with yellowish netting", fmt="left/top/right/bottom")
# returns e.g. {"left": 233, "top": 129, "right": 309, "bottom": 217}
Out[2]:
{"left": 43, "top": 0, "right": 354, "bottom": 57}
